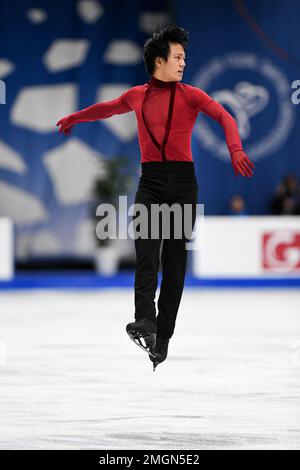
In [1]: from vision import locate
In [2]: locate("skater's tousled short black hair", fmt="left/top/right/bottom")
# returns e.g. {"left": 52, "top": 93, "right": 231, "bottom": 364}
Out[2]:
{"left": 143, "top": 24, "right": 189, "bottom": 75}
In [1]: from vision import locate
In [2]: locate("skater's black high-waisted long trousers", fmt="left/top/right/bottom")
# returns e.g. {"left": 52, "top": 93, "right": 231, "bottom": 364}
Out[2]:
{"left": 133, "top": 161, "right": 198, "bottom": 338}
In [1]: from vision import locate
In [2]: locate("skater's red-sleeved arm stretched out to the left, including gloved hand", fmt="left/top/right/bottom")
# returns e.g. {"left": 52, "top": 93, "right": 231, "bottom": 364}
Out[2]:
{"left": 56, "top": 90, "right": 132, "bottom": 135}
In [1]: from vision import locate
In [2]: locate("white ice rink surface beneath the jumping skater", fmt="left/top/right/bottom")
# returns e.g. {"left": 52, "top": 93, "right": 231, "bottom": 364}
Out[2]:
{"left": 0, "top": 289, "right": 300, "bottom": 449}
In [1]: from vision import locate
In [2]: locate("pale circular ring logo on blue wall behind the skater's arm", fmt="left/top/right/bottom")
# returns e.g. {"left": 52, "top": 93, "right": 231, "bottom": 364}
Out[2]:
{"left": 193, "top": 52, "right": 295, "bottom": 161}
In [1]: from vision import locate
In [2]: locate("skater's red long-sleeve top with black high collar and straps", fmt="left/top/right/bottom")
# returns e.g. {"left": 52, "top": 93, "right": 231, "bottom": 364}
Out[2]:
{"left": 70, "top": 76, "right": 243, "bottom": 162}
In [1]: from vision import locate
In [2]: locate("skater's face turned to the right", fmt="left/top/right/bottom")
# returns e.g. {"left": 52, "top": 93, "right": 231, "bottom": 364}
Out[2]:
{"left": 155, "top": 43, "right": 185, "bottom": 82}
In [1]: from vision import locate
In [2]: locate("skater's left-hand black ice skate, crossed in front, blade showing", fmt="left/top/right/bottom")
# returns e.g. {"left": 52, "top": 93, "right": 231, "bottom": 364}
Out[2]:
{"left": 126, "top": 318, "right": 156, "bottom": 357}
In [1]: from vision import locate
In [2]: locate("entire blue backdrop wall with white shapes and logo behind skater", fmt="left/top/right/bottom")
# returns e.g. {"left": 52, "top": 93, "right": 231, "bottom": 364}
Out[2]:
{"left": 0, "top": 0, "right": 300, "bottom": 258}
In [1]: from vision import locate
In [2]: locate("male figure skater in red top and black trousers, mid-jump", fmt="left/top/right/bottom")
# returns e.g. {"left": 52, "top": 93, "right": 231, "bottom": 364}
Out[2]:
{"left": 57, "top": 25, "right": 254, "bottom": 370}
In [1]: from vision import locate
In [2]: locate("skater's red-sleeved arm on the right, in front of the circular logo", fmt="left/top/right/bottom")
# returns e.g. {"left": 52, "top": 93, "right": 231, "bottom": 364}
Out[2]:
{"left": 190, "top": 87, "right": 254, "bottom": 177}
